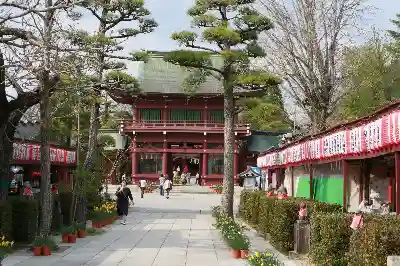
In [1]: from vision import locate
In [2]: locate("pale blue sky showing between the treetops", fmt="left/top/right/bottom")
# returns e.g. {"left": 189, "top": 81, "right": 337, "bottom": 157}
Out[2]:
{"left": 78, "top": 0, "right": 400, "bottom": 78}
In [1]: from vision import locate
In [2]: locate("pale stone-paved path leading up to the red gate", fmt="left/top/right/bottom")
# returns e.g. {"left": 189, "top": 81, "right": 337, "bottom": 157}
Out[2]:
{"left": 3, "top": 188, "right": 246, "bottom": 266}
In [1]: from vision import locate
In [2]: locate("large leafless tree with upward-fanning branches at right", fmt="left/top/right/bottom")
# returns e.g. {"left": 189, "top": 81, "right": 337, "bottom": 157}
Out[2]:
{"left": 260, "top": 0, "right": 366, "bottom": 133}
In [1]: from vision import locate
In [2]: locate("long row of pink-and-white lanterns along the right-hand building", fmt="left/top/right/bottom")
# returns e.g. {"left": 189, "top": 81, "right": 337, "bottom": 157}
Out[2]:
{"left": 257, "top": 110, "right": 400, "bottom": 167}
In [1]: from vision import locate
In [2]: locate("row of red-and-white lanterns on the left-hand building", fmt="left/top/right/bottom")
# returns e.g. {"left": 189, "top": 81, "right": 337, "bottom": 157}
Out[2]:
{"left": 13, "top": 143, "right": 76, "bottom": 164}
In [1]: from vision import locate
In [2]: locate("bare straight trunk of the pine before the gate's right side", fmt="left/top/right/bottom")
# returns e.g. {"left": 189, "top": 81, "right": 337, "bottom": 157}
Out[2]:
{"left": 221, "top": 81, "right": 235, "bottom": 217}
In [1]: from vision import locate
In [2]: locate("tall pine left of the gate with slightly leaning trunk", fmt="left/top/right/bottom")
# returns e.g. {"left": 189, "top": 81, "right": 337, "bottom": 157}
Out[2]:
{"left": 71, "top": 0, "right": 157, "bottom": 222}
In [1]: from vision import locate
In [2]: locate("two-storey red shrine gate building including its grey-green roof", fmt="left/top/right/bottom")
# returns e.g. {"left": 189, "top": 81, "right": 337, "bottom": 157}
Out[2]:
{"left": 113, "top": 52, "right": 255, "bottom": 185}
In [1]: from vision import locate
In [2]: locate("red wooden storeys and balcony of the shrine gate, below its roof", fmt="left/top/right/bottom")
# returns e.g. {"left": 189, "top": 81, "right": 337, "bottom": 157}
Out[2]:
{"left": 121, "top": 94, "right": 250, "bottom": 184}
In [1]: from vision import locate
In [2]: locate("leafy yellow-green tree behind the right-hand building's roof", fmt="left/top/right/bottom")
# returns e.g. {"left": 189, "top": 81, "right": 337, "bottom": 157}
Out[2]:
{"left": 339, "top": 17, "right": 400, "bottom": 120}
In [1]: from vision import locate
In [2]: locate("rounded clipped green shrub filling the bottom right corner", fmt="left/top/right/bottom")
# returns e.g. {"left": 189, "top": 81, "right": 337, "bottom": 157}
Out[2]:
{"left": 347, "top": 216, "right": 400, "bottom": 266}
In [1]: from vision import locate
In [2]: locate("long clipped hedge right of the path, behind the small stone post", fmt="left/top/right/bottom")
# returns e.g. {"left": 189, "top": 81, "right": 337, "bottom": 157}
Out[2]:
{"left": 239, "top": 190, "right": 343, "bottom": 252}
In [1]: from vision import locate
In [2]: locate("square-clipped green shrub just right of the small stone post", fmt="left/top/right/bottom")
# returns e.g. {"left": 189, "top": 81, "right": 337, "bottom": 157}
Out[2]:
{"left": 309, "top": 212, "right": 352, "bottom": 266}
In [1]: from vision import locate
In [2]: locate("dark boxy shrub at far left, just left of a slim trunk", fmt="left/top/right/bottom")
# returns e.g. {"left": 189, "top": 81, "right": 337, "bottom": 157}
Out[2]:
{"left": 11, "top": 199, "right": 39, "bottom": 242}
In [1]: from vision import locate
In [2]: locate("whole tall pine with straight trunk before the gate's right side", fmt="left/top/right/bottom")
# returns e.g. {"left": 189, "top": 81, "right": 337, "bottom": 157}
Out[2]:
{"left": 164, "top": 0, "right": 280, "bottom": 216}
